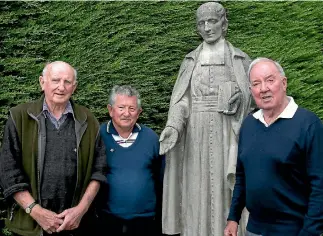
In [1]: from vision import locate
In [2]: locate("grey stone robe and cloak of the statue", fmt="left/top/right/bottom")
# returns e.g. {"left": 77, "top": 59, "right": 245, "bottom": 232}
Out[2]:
{"left": 163, "top": 41, "right": 251, "bottom": 236}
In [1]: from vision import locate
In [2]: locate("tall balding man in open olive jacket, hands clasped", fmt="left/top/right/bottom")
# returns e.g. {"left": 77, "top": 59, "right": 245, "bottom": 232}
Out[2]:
{"left": 0, "top": 61, "right": 106, "bottom": 236}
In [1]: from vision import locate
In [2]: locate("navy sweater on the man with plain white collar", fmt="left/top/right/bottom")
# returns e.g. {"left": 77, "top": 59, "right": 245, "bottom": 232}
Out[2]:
{"left": 228, "top": 108, "right": 323, "bottom": 236}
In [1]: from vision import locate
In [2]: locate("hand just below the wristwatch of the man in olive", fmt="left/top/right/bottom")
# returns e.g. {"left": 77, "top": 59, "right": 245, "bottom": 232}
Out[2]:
{"left": 30, "top": 204, "right": 64, "bottom": 234}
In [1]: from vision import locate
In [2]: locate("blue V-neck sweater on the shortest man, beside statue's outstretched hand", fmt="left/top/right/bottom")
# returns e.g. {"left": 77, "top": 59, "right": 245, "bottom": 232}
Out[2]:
{"left": 100, "top": 122, "right": 163, "bottom": 219}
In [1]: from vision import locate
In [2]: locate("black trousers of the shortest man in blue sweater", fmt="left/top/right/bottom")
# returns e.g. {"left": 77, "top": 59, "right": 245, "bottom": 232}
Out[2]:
{"left": 97, "top": 213, "right": 161, "bottom": 236}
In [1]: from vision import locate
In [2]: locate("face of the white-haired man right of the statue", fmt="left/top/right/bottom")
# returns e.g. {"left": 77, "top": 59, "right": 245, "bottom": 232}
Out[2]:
{"left": 250, "top": 61, "right": 287, "bottom": 111}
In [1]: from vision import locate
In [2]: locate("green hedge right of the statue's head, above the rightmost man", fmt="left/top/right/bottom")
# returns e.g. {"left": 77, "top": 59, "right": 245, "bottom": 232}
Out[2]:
{"left": 227, "top": 1, "right": 323, "bottom": 119}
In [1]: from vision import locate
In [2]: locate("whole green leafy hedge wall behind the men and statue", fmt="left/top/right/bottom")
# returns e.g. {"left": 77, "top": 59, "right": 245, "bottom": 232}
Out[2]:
{"left": 0, "top": 1, "right": 323, "bottom": 230}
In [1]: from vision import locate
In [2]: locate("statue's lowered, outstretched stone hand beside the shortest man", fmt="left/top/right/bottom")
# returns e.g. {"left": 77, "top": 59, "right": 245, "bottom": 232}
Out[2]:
{"left": 159, "top": 126, "right": 178, "bottom": 155}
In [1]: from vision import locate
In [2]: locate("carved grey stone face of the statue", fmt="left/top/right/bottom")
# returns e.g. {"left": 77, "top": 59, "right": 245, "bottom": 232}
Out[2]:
{"left": 197, "top": 8, "right": 224, "bottom": 44}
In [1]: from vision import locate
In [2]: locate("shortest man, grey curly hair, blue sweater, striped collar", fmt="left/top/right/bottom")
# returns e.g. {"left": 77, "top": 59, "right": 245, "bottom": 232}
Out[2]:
{"left": 99, "top": 85, "right": 164, "bottom": 236}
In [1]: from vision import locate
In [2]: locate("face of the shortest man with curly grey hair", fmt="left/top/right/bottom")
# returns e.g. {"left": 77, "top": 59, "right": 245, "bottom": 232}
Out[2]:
{"left": 108, "top": 94, "right": 142, "bottom": 131}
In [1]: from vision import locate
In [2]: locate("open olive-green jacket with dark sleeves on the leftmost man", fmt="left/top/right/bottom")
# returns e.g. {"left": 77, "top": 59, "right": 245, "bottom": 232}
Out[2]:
{"left": 0, "top": 96, "right": 106, "bottom": 236}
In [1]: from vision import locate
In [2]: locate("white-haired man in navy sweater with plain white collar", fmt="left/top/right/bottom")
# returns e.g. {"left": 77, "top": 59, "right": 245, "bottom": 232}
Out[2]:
{"left": 224, "top": 58, "right": 323, "bottom": 236}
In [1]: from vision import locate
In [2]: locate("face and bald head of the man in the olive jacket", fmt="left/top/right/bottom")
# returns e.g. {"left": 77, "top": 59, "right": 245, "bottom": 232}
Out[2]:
{"left": 39, "top": 63, "right": 76, "bottom": 106}
